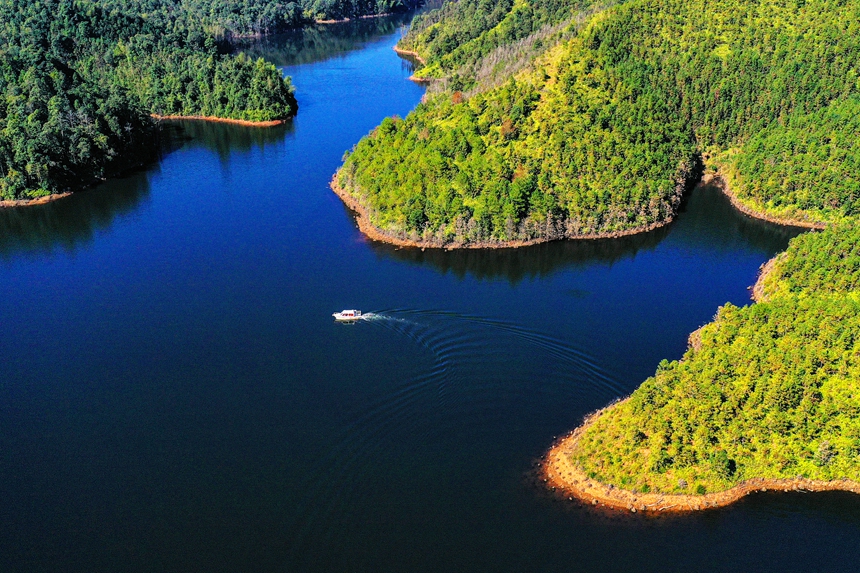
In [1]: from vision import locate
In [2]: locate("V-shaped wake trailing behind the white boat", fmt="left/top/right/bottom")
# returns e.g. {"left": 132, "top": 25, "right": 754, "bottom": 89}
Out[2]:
{"left": 292, "top": 308, "right": 627, "bottom": 553}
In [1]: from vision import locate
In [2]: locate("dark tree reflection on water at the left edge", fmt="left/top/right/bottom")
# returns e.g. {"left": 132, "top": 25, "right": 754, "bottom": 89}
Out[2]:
{"left": 0, "top": 168, "right": 151, "bottom": 259}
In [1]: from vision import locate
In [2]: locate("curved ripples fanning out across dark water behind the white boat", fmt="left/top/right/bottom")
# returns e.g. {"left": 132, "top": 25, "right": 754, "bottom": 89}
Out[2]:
{"left": 291, "top": 309, "right": 624, "bottom": 560}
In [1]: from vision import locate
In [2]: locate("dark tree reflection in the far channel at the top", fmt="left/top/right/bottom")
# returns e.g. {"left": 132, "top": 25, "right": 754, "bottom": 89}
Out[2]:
{"left": 238, "top": 12, "right": 415, "bottom": 66}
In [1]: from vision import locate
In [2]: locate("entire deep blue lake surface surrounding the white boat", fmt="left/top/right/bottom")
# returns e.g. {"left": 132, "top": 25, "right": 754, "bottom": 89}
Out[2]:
{"left": 0, "top": 15, "right": 860, "bottom": 573}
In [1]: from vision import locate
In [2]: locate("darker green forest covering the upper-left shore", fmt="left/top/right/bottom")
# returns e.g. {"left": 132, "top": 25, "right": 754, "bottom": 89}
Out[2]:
{"left": 0, "top": 0, "right": 310, "bottom": 199}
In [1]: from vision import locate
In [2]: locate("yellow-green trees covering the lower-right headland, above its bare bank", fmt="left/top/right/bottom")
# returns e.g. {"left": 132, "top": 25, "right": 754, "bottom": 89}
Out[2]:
{"left": 574, "top": 227, "right": 860, "bottom": 493}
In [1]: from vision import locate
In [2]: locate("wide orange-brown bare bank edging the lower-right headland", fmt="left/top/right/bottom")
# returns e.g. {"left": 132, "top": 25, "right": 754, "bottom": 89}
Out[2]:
{"left": 541, "top": 404, "right": 860, "bottom": 513}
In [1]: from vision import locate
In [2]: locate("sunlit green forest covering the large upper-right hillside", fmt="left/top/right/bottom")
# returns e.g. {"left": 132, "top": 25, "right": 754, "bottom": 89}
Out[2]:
{"left": 338, "top": 0, "right": 860, "bottom": 244}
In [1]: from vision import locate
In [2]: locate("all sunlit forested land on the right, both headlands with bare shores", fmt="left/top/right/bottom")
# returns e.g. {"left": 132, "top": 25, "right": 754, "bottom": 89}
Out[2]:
{"left": 333, "top": 0, "right": 860, "bottom": 504}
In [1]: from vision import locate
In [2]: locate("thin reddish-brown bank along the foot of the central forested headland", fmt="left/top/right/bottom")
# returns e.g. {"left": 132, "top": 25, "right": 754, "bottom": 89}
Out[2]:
{"left": 330, "top": 175, "right": 672, "bottom": 249}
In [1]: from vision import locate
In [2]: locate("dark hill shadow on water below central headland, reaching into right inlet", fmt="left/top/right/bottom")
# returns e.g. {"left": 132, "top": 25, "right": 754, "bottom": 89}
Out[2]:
{"left": 371, "top": 180, "right": 805, "bottom": 284}
